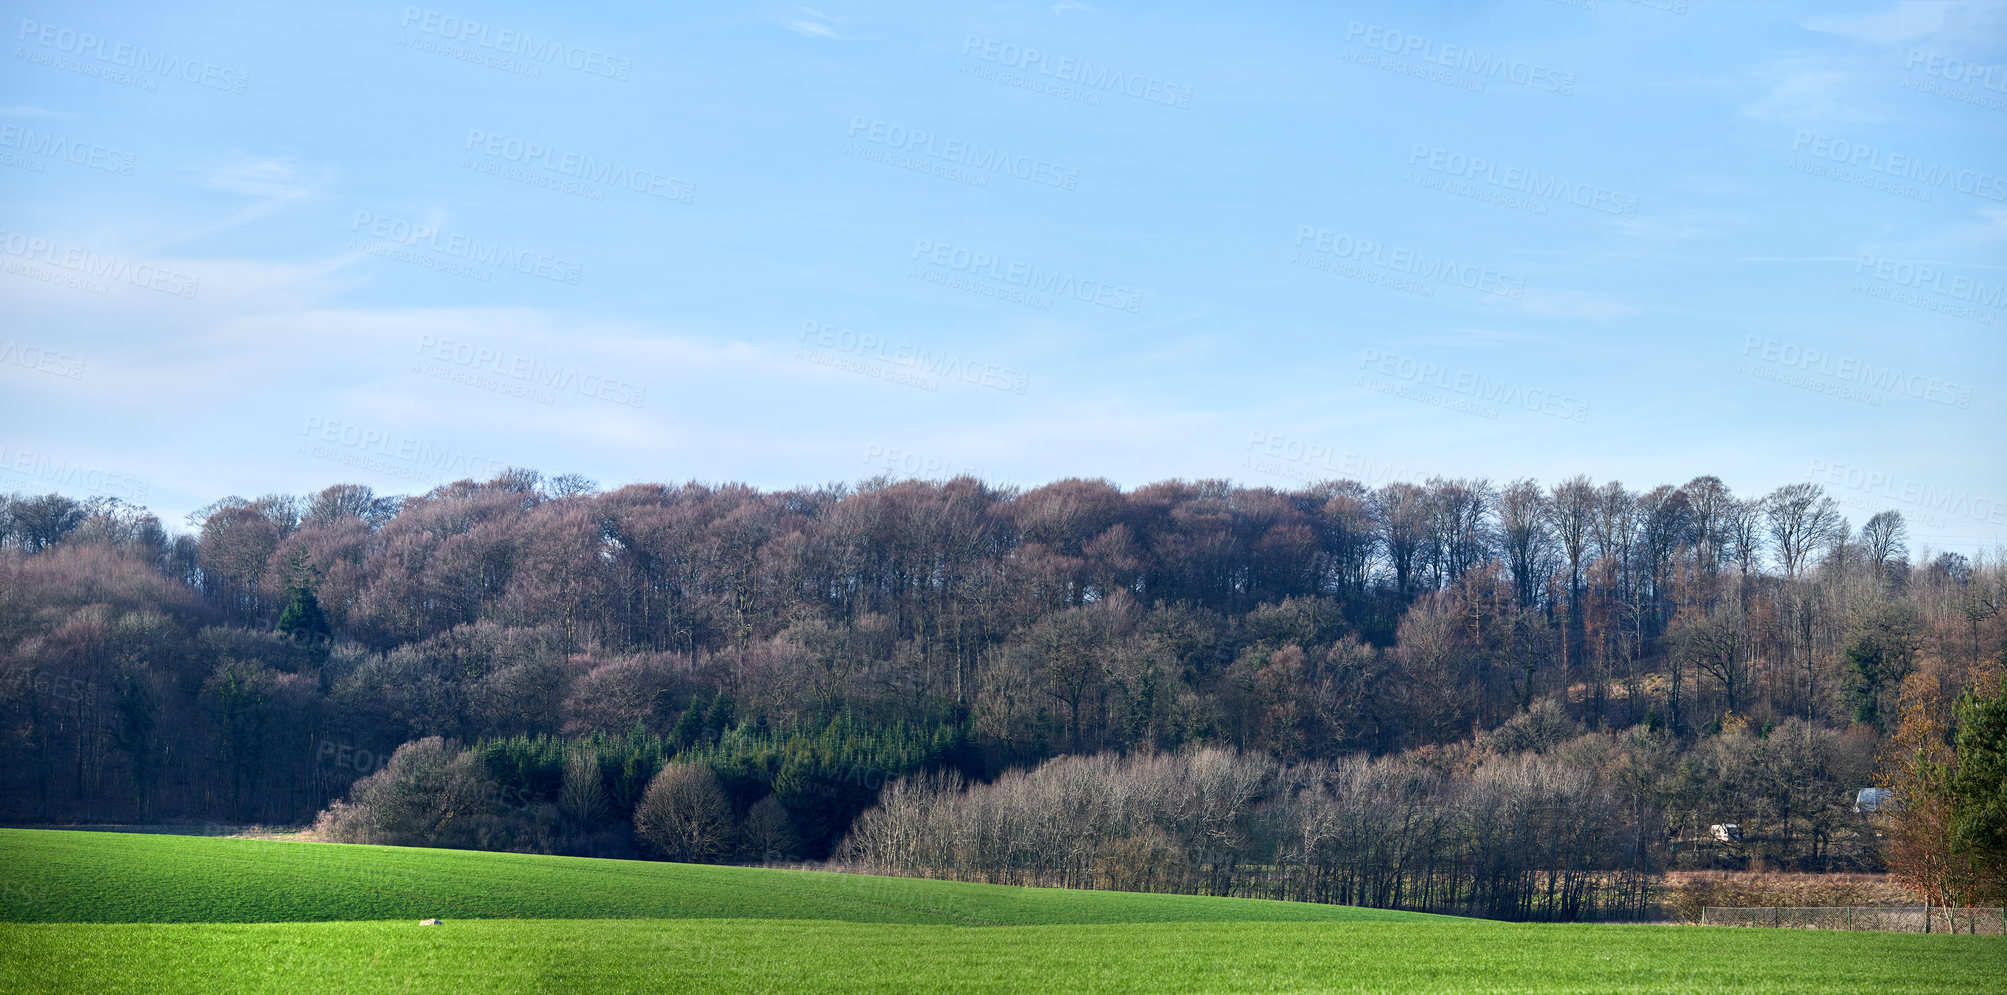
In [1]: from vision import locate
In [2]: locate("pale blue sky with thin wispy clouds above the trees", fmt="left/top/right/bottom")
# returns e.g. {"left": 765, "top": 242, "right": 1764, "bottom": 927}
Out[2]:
{"left": 0, "top": 0, "right": 2007, "bottom": 552}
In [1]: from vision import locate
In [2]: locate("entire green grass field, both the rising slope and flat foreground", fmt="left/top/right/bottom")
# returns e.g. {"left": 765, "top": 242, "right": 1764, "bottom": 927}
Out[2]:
{"left": 0, "top": 831, "right": 2007, "bottom": 993}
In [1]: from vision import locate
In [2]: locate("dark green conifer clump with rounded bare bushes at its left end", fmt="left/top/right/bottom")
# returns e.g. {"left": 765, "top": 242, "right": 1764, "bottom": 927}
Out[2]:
{"left": 315, "top": 714, "right": 963, "bottom": 863}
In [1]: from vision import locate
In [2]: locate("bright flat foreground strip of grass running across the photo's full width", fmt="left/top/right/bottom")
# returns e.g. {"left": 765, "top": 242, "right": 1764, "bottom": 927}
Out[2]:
{"left": 0, "top": 919, "right": 2007, "bottom": 995}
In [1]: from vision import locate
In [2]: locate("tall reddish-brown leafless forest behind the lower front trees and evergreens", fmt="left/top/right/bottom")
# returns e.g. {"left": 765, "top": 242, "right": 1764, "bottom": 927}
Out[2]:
{"left": 0, "top": 471, "right": 2007, "bottom": 914}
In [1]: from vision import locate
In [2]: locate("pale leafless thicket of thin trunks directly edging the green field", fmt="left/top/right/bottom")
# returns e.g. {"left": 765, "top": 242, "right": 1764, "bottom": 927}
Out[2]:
{"left": 841, "top": 736, "right": 1654, "bottom": 921}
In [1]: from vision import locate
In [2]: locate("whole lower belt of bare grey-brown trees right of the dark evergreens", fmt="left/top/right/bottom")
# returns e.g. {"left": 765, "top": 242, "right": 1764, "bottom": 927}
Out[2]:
{"left": 837, "top": 702, "right": 1910, "bottom": 921}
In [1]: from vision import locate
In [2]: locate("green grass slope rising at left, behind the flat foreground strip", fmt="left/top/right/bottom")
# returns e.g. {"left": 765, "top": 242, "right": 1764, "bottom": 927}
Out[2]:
{"left": 0, "top": 828, "right": 1431, "bottom": 925}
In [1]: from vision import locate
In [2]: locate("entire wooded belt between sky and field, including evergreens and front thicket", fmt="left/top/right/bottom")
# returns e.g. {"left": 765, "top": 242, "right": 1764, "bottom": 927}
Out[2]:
{"left": 0, "top": 469, "right": 2007, "bottom": 919}
